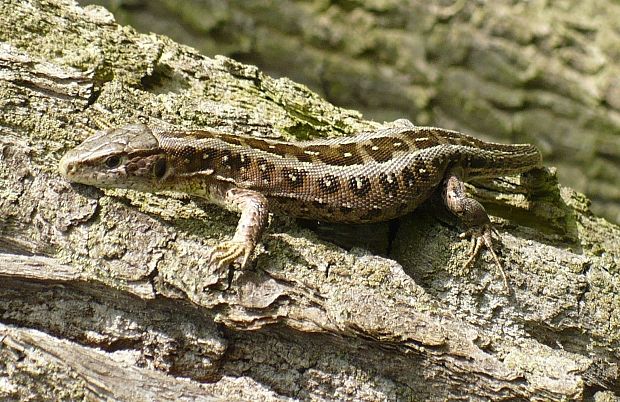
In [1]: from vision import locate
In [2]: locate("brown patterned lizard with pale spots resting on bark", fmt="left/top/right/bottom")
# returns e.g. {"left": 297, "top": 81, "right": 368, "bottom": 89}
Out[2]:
{"left": 59, "top": 119, "right": 542, "bottom": 288}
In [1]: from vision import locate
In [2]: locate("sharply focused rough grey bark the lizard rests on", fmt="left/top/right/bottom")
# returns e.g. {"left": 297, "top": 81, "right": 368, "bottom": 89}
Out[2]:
{"left": 0, "top": 0, "right": 620, "bottom": 401}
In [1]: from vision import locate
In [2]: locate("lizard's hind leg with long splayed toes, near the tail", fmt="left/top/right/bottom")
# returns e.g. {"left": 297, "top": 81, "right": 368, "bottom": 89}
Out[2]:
{"left": 442, "top": 171, "right": 508, "bottom": 290}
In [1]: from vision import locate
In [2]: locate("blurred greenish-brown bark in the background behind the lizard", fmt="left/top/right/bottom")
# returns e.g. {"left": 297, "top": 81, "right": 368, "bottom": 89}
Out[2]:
{"left": 82, "top": 0, "right": 620, "bottom": 223}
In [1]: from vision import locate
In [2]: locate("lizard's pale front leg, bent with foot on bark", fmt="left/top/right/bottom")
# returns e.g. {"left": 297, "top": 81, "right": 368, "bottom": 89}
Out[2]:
{"left": 209, "top": 188, "right": 269, "bottom": 269}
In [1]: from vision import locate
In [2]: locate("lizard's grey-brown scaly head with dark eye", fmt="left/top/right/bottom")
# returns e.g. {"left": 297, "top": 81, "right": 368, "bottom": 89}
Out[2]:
{"left": 58, "top": 124, "right": 170, "bottom": 191}
